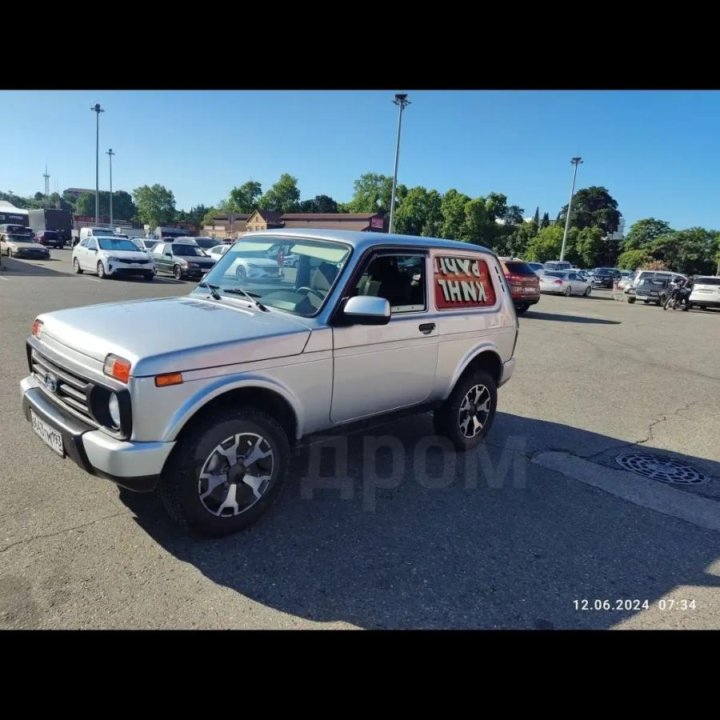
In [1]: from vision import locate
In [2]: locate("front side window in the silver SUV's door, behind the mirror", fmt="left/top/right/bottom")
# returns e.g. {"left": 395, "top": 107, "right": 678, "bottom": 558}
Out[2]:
{"left": 354, "top": 255, "right": 427, "bottom": 315}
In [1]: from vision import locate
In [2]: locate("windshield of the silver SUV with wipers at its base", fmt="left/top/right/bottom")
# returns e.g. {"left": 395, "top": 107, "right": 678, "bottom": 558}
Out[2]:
{"left": 195, "top": 237, "right": 350, "bottom": 317}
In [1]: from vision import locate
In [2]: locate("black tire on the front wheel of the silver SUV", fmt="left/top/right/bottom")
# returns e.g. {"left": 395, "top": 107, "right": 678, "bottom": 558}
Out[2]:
{"left": 158, "top": 407, "right": 290, "bottom": 537}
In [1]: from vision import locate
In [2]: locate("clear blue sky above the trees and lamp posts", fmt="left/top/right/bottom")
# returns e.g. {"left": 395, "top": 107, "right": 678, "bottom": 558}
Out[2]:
{"left": 0, "top": 88, "right": 720, "bottom": 229}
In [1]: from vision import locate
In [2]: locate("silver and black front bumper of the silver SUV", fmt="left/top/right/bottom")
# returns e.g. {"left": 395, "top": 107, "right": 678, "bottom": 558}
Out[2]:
{"left": 20, "top": 375, "right": 175, "bottom": 492}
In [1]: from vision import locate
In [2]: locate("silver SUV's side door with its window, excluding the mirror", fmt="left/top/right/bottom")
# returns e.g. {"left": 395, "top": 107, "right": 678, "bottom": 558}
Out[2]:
{"left": 330, "top": 250, "right": 438, "bottom": 423}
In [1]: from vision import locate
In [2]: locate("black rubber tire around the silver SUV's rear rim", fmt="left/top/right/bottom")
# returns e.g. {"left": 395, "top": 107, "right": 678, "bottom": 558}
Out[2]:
{"left": 433, "top": 370, "right": 497, "bottom": 451}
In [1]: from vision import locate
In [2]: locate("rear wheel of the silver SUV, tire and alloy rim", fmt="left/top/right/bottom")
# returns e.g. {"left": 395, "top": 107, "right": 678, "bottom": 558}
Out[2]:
{"left": 433, "top": 370, "right": 497, "bottom": 450}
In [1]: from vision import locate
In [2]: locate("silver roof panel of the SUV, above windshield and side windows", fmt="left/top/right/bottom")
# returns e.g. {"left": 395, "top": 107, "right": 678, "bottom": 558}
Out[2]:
{"left": 240, "top": 228, "right": 495, "bottom": 255}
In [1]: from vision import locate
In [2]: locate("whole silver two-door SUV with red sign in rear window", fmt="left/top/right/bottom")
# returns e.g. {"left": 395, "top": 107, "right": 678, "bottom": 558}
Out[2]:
{"left": 21, "top": 230, "right": 518, "bottom": 535}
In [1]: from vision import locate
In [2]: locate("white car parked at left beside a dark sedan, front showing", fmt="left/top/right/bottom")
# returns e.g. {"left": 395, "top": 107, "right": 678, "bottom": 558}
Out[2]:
{"left": 72, "top": 236, "right": 155, "bottom": 280}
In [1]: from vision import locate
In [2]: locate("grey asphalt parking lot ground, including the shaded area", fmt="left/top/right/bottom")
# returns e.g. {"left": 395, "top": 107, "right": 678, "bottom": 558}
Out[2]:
{"left": 0, "top": 249, "right": 720, "bottom": 630}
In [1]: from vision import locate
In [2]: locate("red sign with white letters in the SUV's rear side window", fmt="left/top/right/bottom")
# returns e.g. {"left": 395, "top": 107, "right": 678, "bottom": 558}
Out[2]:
{"left": 433, "top": 255, "right": 495, "bottom": 309}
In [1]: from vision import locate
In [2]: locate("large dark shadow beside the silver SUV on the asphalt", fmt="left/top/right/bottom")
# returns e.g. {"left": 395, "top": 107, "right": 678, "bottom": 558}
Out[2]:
{"left": 120, "top": 413, "right": 720, "bottom": 629}
